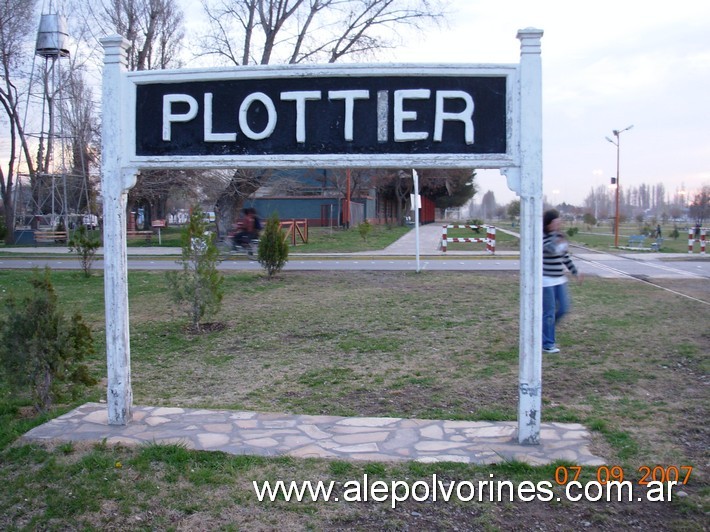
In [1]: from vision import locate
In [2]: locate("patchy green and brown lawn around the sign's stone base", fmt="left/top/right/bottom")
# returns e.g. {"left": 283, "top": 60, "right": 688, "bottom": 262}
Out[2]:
{"left": 0, "top": 270, "right": 710, "bottom": 530}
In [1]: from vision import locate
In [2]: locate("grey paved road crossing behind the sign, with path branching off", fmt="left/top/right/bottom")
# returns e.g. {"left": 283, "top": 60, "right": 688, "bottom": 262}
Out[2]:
{"left": 0, "top": 223, "right": 710, "bottom": 279}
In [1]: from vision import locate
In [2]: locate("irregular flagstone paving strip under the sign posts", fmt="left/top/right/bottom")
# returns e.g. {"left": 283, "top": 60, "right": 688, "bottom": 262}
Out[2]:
{"left": 23, "top": 403, "right": 604, "bottom": 465}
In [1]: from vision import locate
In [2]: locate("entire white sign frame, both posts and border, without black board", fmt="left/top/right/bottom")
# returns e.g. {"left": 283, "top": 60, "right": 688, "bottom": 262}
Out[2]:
{"left": 101, "top": 28, "right": 543, "bottom": 444}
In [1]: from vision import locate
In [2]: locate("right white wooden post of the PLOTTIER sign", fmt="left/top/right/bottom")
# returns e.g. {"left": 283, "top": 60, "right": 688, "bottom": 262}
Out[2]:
{"left": 517, "top": 28, "right": 543, "bottom": 445}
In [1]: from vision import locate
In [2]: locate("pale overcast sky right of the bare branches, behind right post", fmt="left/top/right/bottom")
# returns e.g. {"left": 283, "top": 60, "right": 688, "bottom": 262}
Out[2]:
{"left": 378, "top": 0, "right": 710, "bottom": 204}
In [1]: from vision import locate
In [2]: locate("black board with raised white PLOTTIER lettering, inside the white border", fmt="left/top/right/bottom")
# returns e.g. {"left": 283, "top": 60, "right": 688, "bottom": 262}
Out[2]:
{"left": 135, "top": 75, "right": 508, "bottom": 157}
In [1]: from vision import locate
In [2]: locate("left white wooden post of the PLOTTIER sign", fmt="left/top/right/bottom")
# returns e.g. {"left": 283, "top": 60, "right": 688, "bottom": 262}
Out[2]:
{"left": 101, "top": 35, "right": 137, "bottom": 425}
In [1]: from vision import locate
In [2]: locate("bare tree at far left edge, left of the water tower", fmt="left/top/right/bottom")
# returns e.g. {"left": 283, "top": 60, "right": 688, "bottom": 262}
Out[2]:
{"left": 0, "top": 0, "right": 37, "bottom": 244}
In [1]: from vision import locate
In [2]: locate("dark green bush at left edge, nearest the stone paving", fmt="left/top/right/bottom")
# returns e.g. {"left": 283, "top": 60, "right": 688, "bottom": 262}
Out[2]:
{"left": 0, "top": 268, "right": 96, "bottom": 411}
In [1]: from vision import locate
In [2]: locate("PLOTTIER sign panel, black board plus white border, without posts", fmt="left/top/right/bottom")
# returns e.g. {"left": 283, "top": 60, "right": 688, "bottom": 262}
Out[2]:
{"left": 125, "top": 65, "right": 518, "bottom": 168}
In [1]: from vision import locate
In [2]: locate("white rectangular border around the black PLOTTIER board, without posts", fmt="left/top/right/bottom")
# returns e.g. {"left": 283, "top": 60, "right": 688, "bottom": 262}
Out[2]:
{"left": 123, "top": 64, "right": 520, "bottom": 169}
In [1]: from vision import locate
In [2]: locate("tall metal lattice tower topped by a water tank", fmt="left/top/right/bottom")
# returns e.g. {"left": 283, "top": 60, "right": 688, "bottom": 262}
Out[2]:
{"left": 16, "top": 4, "right": 98, "bottom": 237}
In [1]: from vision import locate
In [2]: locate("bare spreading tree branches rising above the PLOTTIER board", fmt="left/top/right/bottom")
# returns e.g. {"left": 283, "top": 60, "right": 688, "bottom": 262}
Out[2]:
{"left": 200, "top": 0, "right": 443, "bottom": 65}
